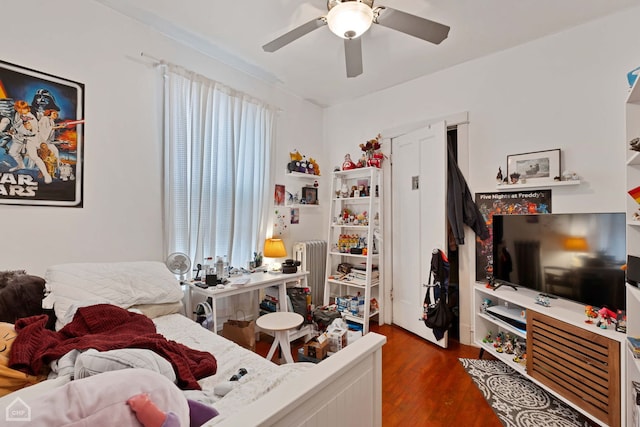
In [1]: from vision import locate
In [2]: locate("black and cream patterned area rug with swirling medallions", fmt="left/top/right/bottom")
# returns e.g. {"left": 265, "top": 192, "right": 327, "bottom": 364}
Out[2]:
{"left": 460, "top": 359, "right": 598, "bottom": 427}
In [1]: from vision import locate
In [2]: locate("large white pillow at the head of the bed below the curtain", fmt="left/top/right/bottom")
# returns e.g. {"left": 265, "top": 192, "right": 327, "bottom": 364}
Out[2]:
{"left": 45, "top": 261, "right": 183, "bottom": 330}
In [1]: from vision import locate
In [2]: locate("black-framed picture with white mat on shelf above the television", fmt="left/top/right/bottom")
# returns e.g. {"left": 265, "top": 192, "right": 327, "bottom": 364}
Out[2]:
{"left": 507, "top": 148, "right": 560, "bottom": 184}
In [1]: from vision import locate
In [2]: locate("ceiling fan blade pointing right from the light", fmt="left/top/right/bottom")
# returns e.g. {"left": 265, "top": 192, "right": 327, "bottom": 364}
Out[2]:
{"left": 373, "top": 6, "right": 450, "bottom": 44}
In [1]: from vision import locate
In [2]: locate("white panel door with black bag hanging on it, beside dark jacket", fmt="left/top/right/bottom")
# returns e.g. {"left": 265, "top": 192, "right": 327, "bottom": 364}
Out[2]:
{"left": 391, "top": 122, "right": 448, "bottom": 347}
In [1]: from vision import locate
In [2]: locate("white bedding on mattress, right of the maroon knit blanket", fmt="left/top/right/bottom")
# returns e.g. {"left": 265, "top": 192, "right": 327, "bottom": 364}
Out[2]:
{"left": 153, "top": 314, "right": 314, "bottom": 424}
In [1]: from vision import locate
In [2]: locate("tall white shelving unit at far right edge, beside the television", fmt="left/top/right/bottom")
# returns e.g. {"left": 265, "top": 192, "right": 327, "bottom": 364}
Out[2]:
{"left": 622, "top": 80, "right": 640, "bottom": 426}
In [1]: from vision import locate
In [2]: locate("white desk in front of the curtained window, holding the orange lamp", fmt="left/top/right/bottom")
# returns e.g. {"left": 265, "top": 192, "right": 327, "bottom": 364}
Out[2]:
{"left": 187, "top": 271, "right": 309, "bottom": 334}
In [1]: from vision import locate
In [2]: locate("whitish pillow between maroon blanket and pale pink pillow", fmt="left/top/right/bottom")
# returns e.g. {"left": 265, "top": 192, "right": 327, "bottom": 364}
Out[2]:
{"left": 73, "top": 348, "right": 176, "bottom": 383}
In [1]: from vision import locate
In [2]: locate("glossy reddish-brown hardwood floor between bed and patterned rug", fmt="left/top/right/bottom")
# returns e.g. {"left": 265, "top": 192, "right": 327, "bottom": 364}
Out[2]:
{"left": 256, "top": 324, "right": 502, "bottom": 427}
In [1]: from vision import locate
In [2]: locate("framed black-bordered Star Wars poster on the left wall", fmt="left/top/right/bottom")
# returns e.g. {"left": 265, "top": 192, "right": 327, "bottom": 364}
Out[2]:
{"left": 0, "top": 61, "right": 84, "bottom": 207}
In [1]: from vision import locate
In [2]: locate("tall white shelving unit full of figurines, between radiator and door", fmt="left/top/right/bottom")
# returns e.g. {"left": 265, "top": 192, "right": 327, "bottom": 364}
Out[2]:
{"left": 324, "top": 167, "right": 384, "bottom": 334}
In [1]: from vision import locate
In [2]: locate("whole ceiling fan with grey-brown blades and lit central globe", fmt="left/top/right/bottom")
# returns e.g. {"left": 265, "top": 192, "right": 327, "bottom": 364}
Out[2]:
{"left": 262, "top": 0, "right": 450, "bottom": 77}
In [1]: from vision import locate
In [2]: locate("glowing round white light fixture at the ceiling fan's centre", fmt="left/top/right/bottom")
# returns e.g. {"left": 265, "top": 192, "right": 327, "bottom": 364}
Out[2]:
{"left": 327, "top": 1, "right": 373, "bottom": 39}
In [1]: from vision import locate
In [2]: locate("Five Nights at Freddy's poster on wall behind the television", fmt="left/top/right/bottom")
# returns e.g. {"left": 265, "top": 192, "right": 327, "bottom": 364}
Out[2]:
{"left": 476, "top": 190, "right": 551, "bottom": 282}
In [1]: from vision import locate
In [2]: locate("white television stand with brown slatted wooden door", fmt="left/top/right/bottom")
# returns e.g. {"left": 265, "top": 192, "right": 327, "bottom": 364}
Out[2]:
{"left": 473, "top": 280, "right": 624, "bottom": 427}
